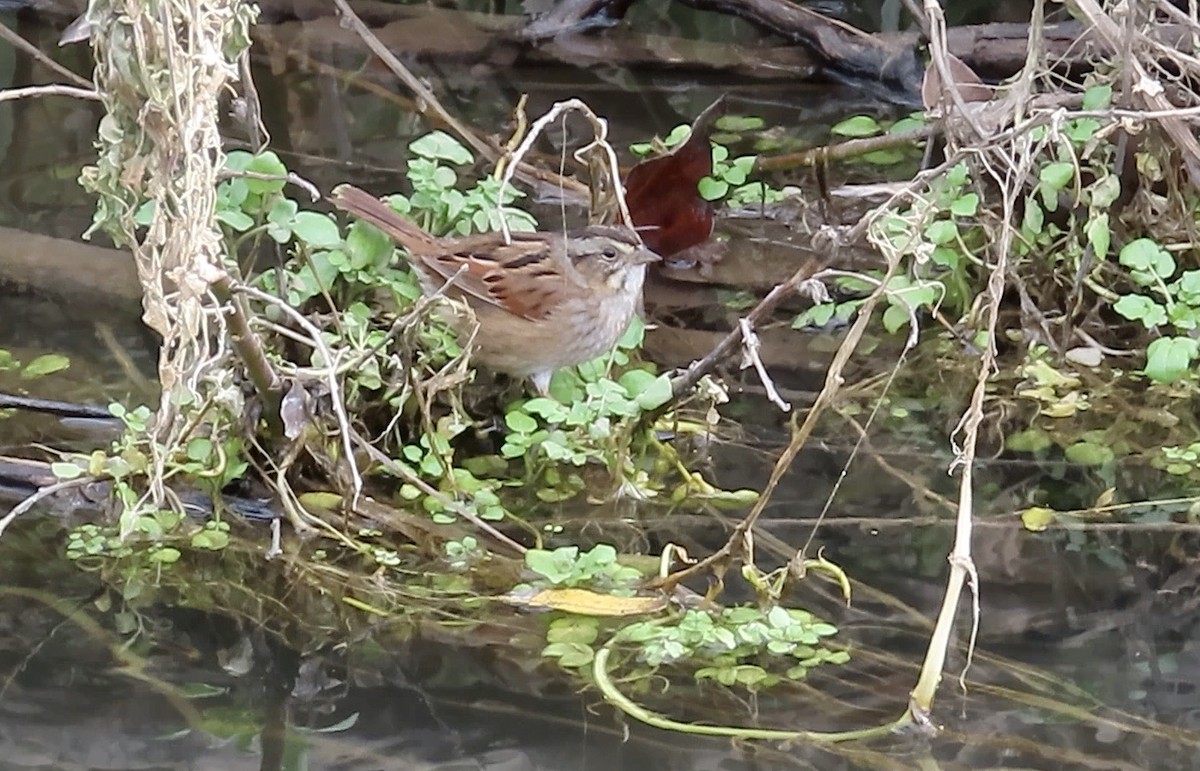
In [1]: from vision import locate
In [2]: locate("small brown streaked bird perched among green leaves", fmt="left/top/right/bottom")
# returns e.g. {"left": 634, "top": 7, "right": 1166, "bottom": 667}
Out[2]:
{"left": 330, "top": 185, "right": 661, "bottom": 395}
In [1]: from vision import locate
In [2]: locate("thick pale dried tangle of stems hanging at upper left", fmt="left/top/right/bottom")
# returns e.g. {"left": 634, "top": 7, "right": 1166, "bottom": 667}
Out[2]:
{"left": 82, "top": 0, "right": 253, "bottom": 523}
